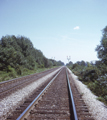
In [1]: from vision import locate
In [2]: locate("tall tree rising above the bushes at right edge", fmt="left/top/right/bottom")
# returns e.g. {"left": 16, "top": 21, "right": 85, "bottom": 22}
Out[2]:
{"left": 96, "top": 26, "right": 107, "bottom": 65}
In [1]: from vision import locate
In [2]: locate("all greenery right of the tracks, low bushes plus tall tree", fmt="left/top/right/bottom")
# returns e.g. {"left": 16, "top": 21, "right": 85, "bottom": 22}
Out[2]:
{"left": 67, "top": 26, "right": 107, "bottom": 104}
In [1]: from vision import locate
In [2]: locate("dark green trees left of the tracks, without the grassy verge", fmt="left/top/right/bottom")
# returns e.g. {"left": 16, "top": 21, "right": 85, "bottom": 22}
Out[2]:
{"left": 0, "top": 35, "right": 62, "bottom": 70}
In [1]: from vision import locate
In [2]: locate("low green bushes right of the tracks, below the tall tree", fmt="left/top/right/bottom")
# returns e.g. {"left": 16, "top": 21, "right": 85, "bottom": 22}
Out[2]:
{"left": 69, "top": 61, "right": 107, "bottom": 104}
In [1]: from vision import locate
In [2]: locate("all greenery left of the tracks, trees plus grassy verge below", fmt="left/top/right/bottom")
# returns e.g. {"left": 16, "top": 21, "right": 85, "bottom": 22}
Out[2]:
{"left": 0, "top": 35, "right": 64, "bottom": 81}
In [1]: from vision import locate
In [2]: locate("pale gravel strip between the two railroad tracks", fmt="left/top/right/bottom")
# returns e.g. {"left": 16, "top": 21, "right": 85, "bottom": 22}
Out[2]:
{"left": 0, "top": 68, "right": 61, "bottom": 120}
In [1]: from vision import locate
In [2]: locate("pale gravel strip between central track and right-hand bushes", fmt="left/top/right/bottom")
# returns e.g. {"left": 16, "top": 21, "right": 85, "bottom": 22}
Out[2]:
{"left": 68, "top": 69, "right": 107, "bottom": 120}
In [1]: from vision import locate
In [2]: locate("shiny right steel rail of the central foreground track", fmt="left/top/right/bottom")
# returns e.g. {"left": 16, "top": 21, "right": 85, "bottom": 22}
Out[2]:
{"left": 66, "top": 69, "right": 78, "bottom": 120}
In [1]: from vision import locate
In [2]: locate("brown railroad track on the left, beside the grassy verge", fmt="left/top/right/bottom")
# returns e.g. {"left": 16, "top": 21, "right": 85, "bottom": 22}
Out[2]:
{"left": 0, "top": 68, "right": 58, "bottom": 99}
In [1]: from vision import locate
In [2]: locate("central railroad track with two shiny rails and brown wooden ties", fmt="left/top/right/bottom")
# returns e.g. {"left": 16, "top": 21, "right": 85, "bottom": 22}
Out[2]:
{"left": 7, "top": 67, "right": 94, "bottom": 120}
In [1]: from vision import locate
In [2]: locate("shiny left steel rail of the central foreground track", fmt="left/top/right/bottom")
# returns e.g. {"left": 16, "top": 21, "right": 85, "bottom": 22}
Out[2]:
{"left": 16, "top": 69, "right": 62, "bottom": 120}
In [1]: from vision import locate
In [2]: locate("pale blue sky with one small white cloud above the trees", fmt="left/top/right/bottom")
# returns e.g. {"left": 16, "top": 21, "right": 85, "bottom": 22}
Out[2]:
{"left": 0, "top": 0, "right": 107, "bottom": 63}
